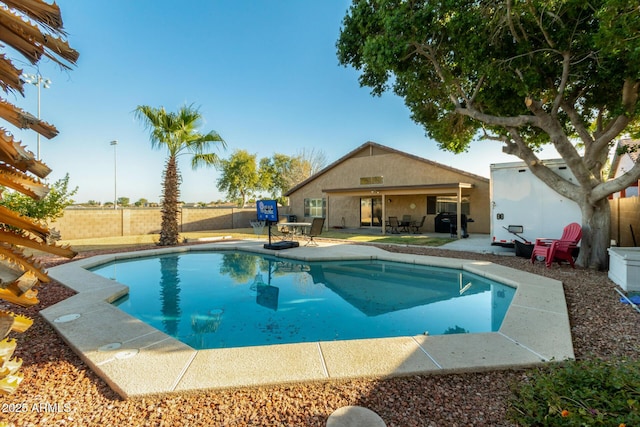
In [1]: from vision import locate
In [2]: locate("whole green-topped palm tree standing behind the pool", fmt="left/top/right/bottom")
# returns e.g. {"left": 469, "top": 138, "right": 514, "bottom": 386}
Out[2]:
{"left": 134, "top": 105, "right": 227, "bottom": 246}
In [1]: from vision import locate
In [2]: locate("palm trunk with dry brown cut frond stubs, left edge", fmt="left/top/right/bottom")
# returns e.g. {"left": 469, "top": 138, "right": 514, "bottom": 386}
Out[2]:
{"left": 0, "top": 0, "right": 78, "bottom": 394}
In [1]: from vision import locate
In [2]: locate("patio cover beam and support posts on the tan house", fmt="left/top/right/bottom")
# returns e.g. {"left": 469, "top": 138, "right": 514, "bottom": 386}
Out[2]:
{"left": 322, "top": 182, "right": 474, "bottom": 239}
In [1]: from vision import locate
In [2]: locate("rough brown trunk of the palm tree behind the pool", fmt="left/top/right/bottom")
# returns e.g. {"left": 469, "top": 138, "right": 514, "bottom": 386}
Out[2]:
{"left": 158, "top": 156, "right": 180, "bottom": 246}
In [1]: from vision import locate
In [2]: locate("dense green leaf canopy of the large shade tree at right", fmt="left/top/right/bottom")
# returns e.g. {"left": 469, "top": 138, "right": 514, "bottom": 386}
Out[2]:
{"left": 337, "top": 0, "right": 640, "bottom": 152}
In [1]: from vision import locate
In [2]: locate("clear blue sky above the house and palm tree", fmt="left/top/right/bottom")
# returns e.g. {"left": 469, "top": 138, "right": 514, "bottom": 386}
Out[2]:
{"left": 7, "top": 0, "right": 553, "bottom": 203}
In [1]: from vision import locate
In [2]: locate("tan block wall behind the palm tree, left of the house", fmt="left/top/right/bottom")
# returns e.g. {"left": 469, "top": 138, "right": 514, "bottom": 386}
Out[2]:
{"left": 49, "top": 207, "right": 256, "bottom": 240}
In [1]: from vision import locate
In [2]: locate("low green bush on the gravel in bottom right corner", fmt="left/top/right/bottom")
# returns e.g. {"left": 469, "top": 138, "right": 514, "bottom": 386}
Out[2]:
{"left": 508, "top": 360, "right": 640, "bottom": 426}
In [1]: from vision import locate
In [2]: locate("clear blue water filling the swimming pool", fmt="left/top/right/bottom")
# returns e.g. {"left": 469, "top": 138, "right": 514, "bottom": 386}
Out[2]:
{"left": 91, "top": 251, "right": 515, "bottom": 349}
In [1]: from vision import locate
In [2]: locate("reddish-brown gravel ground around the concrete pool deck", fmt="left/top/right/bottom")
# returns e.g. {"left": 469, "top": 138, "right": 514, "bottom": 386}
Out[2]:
{"left": 0, "top": 247, "right": 640, "bottom": 427}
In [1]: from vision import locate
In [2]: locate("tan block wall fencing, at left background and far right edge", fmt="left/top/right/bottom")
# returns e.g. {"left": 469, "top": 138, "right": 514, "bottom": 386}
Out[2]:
{"left": 49, "top": 197, "right": 640, "bottom": 247}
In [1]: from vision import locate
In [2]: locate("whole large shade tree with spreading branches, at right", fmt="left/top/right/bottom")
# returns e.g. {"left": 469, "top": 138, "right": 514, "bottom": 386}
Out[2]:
{"left": 337, "top": 0, "right": 640, "bottom": 268}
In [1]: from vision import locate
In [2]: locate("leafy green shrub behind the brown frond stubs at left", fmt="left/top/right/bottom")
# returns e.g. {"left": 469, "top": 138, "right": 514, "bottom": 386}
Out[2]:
{"left": 0, "top": 174, "right": 78, "bottom": 221}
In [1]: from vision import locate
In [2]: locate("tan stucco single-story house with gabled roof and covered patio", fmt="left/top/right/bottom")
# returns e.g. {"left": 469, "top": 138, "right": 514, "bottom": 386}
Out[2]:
{"left": 285, "top": 142, "right": 490, "bottom": 234}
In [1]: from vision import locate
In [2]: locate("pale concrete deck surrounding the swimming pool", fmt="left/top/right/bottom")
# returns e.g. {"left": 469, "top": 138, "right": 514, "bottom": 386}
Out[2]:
{"left": 41, "top": 240, "right": 574, "bottom": 398}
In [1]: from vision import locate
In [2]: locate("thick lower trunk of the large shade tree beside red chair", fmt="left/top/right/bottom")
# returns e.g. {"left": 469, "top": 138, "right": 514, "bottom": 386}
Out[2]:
{"left": 577, "top": 199, "right": 611, "bottom": 270}
